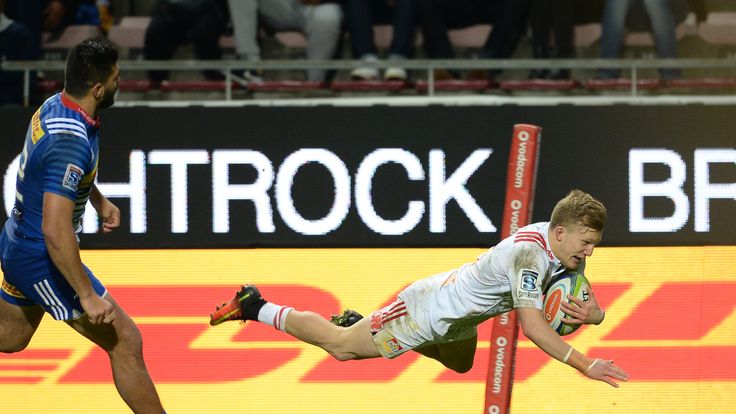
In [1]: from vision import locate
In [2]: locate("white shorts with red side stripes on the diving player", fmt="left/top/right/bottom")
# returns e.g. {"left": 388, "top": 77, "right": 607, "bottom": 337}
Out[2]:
{"left": 371, "top": 299, "right": 478, "bottom": 359}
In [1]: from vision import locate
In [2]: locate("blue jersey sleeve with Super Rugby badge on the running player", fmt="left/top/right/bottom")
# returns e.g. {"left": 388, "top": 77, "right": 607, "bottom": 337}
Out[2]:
{"left": 43, "top": 134, "right": 91, "bottom": 201}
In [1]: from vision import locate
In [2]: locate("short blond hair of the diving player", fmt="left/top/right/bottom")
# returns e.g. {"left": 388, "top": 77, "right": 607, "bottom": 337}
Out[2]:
{"left": 550, "top": 189, "right": 608, "bottom": 231}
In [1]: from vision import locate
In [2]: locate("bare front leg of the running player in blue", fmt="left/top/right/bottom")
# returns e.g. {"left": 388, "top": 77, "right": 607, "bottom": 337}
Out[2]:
{"left": 67, "top": 295, "right": 164, "bottom": 414}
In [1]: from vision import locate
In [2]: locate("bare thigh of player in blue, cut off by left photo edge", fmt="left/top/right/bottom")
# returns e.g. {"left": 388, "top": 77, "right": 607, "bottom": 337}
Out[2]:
{"left": 0, "top": 299, "right": 44, "bottom": 353}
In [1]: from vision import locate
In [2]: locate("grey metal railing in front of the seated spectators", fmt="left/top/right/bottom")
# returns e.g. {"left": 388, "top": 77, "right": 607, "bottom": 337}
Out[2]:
{"left": 0, "top": 58, "right": 736, "bottom": 106}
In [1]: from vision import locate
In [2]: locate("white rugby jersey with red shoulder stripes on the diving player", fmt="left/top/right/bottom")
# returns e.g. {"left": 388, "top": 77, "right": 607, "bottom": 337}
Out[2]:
{"left": 399, "top": 222, "right": 572, "bottom": 338}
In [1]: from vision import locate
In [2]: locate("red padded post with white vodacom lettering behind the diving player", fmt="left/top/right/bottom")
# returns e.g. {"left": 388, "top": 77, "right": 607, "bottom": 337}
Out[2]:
{"left": 483, "top": 124, "right": 542, "bottom": 414}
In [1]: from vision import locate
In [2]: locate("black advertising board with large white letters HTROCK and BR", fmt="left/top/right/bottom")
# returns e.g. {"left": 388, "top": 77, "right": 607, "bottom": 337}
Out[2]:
{"left": 0, "top": 105, "right": 736, "bottom": 248}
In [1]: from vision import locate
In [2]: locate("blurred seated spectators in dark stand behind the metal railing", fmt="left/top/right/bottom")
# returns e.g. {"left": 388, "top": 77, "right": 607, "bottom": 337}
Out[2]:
{"left": 0, "top": 0, "right": 736, "bottom": 105}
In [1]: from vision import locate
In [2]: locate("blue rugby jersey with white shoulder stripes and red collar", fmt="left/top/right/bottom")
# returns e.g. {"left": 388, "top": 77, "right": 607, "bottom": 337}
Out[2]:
{"left": 6, "top": 92, "right": 100, "bottom": 244}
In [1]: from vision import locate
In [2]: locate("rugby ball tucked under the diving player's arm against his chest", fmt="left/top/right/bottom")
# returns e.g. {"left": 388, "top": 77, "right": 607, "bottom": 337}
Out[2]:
{"left": 542, "top": 271, "right": 590, "bottom": 336}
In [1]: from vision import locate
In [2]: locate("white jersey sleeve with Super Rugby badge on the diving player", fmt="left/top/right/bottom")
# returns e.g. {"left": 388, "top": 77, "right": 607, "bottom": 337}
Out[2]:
{"left": 507, "top": 243, "right": 549, "bottom": 310}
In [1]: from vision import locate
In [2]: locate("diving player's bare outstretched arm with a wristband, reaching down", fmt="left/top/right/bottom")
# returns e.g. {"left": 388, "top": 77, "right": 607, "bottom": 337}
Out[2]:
{"left": 517, "top": 308, "right": 629, "bottom": 388}
